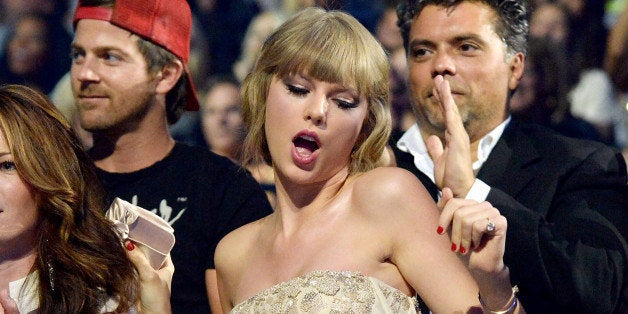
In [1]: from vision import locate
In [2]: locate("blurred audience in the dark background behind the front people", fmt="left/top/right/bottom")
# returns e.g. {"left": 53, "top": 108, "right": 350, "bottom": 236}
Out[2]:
{"left": 0, "top": 0, "right": 628, "bottom": 167}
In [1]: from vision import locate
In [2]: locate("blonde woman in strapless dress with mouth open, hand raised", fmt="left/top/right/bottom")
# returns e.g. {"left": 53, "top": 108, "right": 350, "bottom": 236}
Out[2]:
{"left": 215, "top": 8, "right": 523, "bottom": 313}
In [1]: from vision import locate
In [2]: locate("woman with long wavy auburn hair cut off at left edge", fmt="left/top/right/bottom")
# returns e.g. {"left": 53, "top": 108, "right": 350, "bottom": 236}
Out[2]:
{"left": 0, "top": 85, "right": 174, "bottom": 313}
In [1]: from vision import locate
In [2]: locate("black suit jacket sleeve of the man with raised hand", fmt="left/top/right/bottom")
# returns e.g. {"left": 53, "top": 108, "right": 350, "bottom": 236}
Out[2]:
{"left": 487, "top": 149, "right": 628, "bottom": 313}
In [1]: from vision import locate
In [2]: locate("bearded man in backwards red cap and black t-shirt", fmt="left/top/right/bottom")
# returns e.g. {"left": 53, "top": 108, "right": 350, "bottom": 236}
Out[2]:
{"left": 71, "top": 0, "right": 271, "bottom": 314}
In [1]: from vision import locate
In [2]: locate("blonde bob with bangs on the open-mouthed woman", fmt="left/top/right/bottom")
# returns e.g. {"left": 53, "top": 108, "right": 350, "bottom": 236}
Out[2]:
{"left": 242, "top": 8, "right": 391, "bottom": 172}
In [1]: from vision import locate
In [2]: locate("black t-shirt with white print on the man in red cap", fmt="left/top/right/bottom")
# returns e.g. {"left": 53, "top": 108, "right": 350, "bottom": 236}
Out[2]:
{"left": 98, "top": 143, "right": 272, "bottom": 314}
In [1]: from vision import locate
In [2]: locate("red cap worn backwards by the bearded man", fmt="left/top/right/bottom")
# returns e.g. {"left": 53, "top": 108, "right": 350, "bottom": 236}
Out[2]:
{"left": 74, "top": 0, "right": 199, "bottom": 111}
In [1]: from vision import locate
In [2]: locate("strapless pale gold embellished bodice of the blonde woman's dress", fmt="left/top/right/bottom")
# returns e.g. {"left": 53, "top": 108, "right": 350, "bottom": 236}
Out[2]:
{"left": 231, "top": 270, "right": 417, "bottom": 313}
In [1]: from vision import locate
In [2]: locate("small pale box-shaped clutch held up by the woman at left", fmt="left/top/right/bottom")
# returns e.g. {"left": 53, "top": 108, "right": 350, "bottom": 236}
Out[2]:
{"left": 105, "top": 197, "right": 174, "bottom": 269}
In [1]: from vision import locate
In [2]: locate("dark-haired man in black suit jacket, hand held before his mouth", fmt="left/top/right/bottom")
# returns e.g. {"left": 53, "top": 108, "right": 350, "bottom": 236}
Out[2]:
{"left": 392, "top": 0, "right": 628, "bottom": 313}
